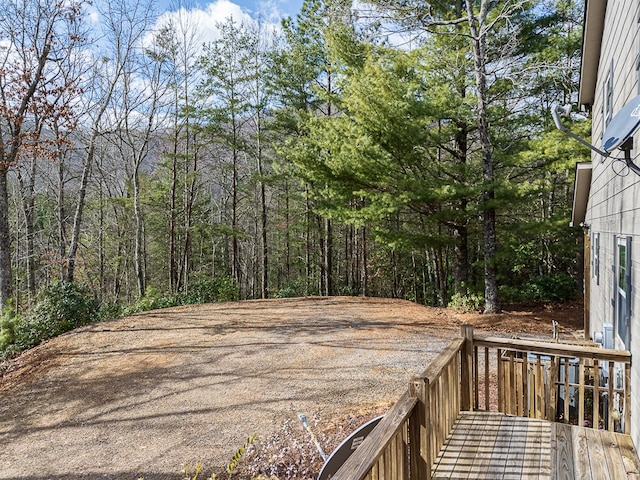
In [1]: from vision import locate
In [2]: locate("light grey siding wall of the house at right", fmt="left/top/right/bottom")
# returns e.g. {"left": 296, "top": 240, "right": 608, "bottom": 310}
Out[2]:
{"left": 585, "top": 0, "right": 640, "bottom": 446}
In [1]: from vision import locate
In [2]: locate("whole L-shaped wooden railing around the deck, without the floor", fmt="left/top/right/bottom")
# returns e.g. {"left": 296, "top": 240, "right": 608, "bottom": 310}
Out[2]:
{"left": 332, "top": 326, "right": 631, "bottom": 480}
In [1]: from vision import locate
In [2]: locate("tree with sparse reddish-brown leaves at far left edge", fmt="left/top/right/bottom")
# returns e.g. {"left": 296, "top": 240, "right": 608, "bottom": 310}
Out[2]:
{"left": 0, "top": 0, "right": 84, "bottom": 306}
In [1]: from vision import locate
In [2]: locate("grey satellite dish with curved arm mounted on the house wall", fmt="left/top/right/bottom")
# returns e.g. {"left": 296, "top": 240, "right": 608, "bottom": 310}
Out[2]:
{"left": 551, "top": 99, "right": 640, "bottom": 175}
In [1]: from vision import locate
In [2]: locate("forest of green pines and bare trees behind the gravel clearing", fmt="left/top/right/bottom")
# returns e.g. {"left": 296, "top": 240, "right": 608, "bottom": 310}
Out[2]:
{"left": 0, "top": 0, "right": 590, "bottom": 318}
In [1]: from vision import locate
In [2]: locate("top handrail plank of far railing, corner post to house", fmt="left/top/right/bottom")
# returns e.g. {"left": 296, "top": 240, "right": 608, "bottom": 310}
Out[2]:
{"left": 473, "top": 334, "right": 631, "bottom": 363}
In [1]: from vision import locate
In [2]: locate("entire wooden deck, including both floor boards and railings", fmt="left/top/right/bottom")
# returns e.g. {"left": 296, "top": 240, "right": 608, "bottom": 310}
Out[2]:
{"left": 332, "top": 325, "right": 640, "bottom": 480}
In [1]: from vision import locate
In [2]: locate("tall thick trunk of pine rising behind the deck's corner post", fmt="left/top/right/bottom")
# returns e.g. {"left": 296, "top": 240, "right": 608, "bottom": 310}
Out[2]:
{"left": 466, "top": 0, "right": 500, "bottom": 313}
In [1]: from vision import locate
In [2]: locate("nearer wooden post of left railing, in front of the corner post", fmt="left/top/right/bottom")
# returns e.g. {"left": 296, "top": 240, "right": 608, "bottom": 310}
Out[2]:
{"left": 409, "top": 377, "right": 434, "bottom": 480}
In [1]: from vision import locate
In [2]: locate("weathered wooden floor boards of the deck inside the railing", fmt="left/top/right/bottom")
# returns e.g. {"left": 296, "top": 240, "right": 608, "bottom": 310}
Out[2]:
{"left": 432, "top": 412, "right": 640, "bottom": 480}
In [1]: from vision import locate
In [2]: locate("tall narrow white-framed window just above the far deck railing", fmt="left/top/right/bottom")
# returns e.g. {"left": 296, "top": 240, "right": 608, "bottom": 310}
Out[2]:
{"left": 614, "top": 236, "right": 632, "bottom": 350}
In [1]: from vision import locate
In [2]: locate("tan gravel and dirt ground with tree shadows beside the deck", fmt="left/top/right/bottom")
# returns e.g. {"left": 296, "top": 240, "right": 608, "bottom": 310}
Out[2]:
{"left": 0, "top": 297, "right": 582, "bottom": 480}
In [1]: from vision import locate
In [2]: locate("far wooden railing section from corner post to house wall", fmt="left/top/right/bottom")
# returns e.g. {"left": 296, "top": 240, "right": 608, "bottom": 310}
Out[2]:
{"left": 473, "top": 335, "right": 631, "bottom": 433}
